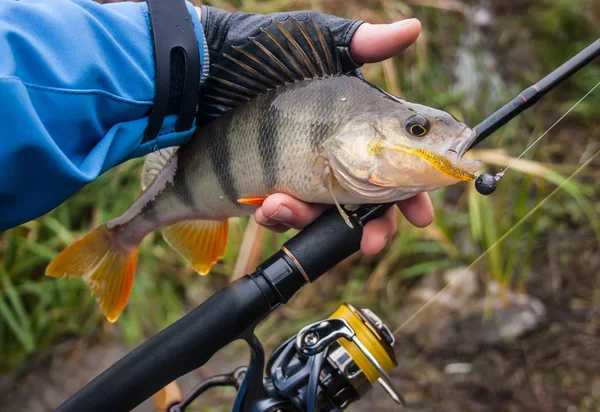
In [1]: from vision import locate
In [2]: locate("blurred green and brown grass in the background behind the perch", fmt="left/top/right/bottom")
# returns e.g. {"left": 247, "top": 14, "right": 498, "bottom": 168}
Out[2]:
{"left": 0, "top": 0, "right": 600, "bottom": 369}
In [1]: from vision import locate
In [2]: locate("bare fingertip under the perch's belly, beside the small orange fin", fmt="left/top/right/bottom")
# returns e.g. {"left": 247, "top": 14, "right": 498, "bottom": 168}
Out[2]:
{"left": 254, "top": 193, "right": 327, "bottom": 231}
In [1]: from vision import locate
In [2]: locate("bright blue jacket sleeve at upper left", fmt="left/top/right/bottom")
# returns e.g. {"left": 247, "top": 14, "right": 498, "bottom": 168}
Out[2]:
{"left": 0, "top": 0, "right": 208, "bottom": 230}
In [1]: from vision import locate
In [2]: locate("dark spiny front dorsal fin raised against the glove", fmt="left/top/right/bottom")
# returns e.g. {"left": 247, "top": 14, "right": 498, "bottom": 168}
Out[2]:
{"left": 200, "top": 17, "right": 342, "bottom": 124}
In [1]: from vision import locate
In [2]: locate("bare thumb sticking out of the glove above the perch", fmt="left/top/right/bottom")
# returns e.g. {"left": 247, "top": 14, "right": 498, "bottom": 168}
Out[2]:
{"left": 350, "top": 19, "right": 421, "bottom": 63}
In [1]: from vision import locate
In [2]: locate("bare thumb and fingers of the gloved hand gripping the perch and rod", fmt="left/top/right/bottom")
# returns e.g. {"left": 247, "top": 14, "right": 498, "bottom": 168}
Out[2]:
{"left": 254, "top": 19, "right": 433, "bottom": 255}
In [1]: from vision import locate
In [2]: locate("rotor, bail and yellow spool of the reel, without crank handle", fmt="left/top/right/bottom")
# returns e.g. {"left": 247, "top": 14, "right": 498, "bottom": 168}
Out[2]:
{"left": 265, "top": 304, "right": 404, "bottom": 412}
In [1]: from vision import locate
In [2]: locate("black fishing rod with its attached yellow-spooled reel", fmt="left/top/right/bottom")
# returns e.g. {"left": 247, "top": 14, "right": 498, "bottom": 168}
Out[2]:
{"left": 56, "top": 40, "right": 600, "bottom": 412}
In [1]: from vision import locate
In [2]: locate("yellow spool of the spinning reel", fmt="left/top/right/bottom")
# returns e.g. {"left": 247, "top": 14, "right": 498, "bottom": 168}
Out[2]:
{"left": 329, "top": 303, "right": 398, "bottom": 383}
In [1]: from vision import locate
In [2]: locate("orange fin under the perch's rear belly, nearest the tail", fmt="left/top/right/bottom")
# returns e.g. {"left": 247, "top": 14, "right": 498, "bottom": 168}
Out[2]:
{"left": 163, "top": 220, "right": 229, "bottom": 275}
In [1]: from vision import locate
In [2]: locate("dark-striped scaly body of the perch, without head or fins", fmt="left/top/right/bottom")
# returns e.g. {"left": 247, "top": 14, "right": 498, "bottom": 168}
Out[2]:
{"left": 114, "top": 76, "right": 398, "bottom": 238}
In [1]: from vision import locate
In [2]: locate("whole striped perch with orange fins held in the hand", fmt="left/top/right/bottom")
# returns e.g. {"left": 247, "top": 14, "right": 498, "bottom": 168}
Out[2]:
{"left": 46, "top": 18, "right": 479, "bottom": 322}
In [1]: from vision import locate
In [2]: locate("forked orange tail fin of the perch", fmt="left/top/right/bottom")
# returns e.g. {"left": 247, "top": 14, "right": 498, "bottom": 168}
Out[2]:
{"left": 46, "top": 225, "right": 138, "bottom": 322}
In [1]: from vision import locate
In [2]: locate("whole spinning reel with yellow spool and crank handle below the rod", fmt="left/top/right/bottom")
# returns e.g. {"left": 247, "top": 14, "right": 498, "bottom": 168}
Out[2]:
{"left": 154, "top": 304, "right": 404, "bottom": 412}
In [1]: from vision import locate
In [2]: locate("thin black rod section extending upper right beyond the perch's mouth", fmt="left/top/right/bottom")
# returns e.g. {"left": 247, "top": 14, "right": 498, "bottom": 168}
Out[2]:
{"left": 468, "top": 39, "right": 600, "bottom": 150}
